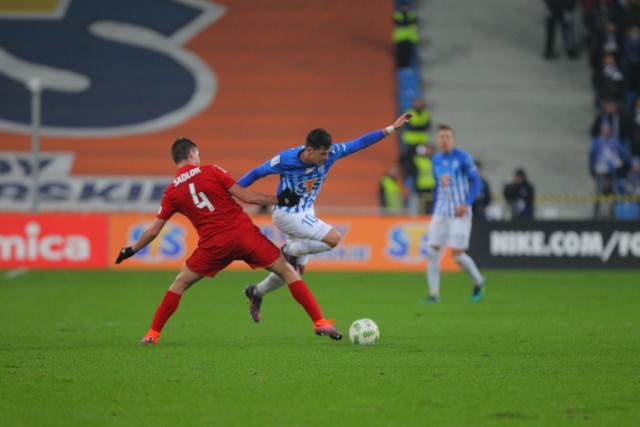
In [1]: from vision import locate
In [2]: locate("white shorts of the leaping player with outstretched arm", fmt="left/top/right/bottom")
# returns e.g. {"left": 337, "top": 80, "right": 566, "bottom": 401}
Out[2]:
{"left": 272, "top": 209, "right": 332, "bottom": 265}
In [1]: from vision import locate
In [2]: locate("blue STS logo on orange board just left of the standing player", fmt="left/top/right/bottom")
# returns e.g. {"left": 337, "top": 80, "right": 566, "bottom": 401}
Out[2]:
{"left": 385, "top": 222, "right": 429, "bottom": 264}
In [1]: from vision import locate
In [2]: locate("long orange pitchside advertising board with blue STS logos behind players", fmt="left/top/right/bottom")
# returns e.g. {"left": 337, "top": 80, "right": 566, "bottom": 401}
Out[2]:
{"left": 109, "top": 214, "right": 459, "bottom": 271}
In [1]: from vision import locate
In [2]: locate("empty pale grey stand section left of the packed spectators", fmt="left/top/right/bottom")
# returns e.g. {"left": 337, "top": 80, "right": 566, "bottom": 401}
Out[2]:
{"left": 410, "top": 0, "right": 593, "bottom": 219}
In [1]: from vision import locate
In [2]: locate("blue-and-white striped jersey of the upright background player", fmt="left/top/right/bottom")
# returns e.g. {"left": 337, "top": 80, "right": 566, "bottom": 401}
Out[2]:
{"left": 433, "top": 148, "right": 482, "bottom": 217}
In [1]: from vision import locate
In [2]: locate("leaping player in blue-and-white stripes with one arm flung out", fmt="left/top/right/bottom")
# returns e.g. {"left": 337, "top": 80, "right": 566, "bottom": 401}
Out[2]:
{"left": 238, "top": 113, "right": 412, "bottom": 322}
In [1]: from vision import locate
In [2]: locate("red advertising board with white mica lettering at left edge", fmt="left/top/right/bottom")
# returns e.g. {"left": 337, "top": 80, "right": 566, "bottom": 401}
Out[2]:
{"left": 0, "top": 214, "right": 108, "bottom": 268}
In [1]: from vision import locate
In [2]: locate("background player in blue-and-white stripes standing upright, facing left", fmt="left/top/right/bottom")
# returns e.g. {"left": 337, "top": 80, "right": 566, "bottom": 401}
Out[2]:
{"left": 421, "top": 125, "right": 485, "bottom": 303}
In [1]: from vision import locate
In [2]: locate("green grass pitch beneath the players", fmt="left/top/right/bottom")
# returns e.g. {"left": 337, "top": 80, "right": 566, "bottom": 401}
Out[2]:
{"left": 0, "top": 271, "right": 640, "bottom": 426}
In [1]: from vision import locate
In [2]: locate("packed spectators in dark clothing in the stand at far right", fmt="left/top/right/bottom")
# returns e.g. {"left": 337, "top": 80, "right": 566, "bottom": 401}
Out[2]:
{"left": 582, "top": 0, "right": 640, "bottom": 220}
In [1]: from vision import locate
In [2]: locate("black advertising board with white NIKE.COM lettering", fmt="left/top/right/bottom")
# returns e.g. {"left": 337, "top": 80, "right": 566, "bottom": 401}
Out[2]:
{"left": 469, "top": 220, "right": 640, "bottom": 269}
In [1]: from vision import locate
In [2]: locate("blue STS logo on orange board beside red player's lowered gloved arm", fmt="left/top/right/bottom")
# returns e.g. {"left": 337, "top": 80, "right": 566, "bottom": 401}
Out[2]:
{"left": 127, "top": 222, "right": 187, "bottom": 264}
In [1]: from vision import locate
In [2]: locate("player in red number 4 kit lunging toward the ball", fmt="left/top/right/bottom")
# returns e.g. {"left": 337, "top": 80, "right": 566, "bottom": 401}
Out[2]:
{"left": 116, "top": 138, "right": 342, "bottom": 344}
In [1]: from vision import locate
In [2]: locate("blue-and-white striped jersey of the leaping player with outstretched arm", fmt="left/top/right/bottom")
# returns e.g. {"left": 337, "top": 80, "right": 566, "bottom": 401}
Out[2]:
{"left": 238, "top": 130, "right": 384, "bottom": 212}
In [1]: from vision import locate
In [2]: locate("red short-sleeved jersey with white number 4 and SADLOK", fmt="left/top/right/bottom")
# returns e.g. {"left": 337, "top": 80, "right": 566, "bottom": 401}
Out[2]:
{"left": 157, "top": 165, "right": 255, "bottom": 249}
